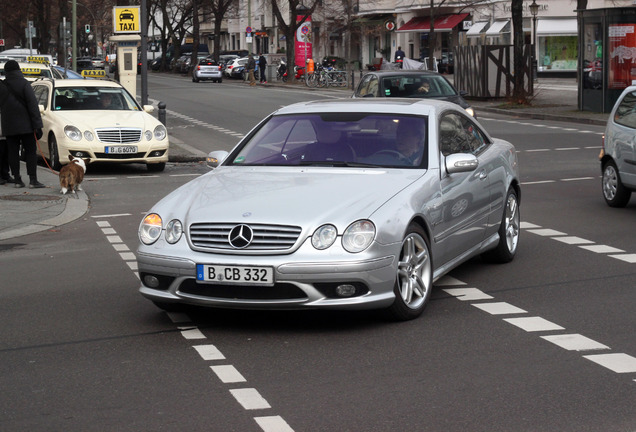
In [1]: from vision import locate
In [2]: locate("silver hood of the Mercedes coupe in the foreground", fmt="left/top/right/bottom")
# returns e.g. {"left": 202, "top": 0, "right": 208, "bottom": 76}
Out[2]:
{"left": 153, "top": 167, "right": 425, "bottom": 228}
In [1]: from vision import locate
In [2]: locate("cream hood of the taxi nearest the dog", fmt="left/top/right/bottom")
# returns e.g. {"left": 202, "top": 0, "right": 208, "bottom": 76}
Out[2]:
{"left": 49, "top": 110, "right": 159, "bottom": 130}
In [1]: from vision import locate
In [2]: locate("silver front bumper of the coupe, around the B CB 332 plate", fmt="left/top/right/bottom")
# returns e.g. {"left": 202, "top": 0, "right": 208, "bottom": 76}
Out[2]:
{"left": 137, "top": 241, "right": 397, "bottom": 309}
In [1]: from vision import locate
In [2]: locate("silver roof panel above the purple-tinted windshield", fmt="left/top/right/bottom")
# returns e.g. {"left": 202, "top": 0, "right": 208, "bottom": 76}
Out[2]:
{"left": 274, "top": 98, "right": 464, "bottom": 115}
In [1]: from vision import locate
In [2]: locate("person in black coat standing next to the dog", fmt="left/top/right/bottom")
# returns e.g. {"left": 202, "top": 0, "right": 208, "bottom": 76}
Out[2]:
{"left": 1, "top": 60, "right": 45, "bottom": 188}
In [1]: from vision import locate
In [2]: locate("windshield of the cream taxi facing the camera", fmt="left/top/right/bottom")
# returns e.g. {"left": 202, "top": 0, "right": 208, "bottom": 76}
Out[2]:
{"left": 53, "top": 86, "right": 141, "bottom": 111}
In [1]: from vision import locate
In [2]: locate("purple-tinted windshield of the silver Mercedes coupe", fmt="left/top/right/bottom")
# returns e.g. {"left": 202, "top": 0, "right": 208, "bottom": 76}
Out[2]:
{"left": 229, "top": 113, "right": 428, "bottom": 168}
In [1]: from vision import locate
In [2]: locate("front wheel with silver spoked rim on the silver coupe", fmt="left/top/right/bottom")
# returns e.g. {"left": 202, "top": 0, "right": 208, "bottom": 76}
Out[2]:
{"left": 387, "top": 223, "right": 433, "bottom": 321}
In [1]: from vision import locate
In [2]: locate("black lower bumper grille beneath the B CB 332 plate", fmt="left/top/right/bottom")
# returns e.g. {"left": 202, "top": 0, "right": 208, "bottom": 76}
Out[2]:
{"left": 179, "top": 279, "right": 307, "bottom": 300}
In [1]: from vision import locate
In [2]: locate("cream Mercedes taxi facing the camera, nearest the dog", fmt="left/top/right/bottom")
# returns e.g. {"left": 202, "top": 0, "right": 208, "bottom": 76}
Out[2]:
{"left": 31, "top": 77, "right": 169, "bottom": 171}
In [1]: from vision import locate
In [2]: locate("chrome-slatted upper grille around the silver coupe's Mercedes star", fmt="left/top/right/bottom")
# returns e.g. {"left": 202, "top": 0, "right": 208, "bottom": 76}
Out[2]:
{"left": 190, "top": 223, "right": 301, "bottom": 251}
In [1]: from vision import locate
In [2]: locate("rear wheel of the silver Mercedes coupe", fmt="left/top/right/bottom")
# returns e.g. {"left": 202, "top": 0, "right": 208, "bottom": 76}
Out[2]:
{"left": 482, "top": 187, "right": 521, "bottom": 263}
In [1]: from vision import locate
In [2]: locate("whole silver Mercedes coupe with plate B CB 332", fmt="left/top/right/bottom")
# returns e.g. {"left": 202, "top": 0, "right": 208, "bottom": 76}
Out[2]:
{"left": 137, "top": 99, "right": 520, "bottom": 320}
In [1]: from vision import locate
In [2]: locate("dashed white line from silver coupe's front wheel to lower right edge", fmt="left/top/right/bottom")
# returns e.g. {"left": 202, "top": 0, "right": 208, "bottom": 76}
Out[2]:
{"left": 436, "top": 282, "right": 636, "bottom": 383}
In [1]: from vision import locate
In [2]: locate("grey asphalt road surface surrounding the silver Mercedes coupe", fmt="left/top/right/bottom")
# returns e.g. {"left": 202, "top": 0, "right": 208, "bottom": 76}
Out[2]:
{"left": 0, "top": 76, "right": 636, "bottom": 432}
